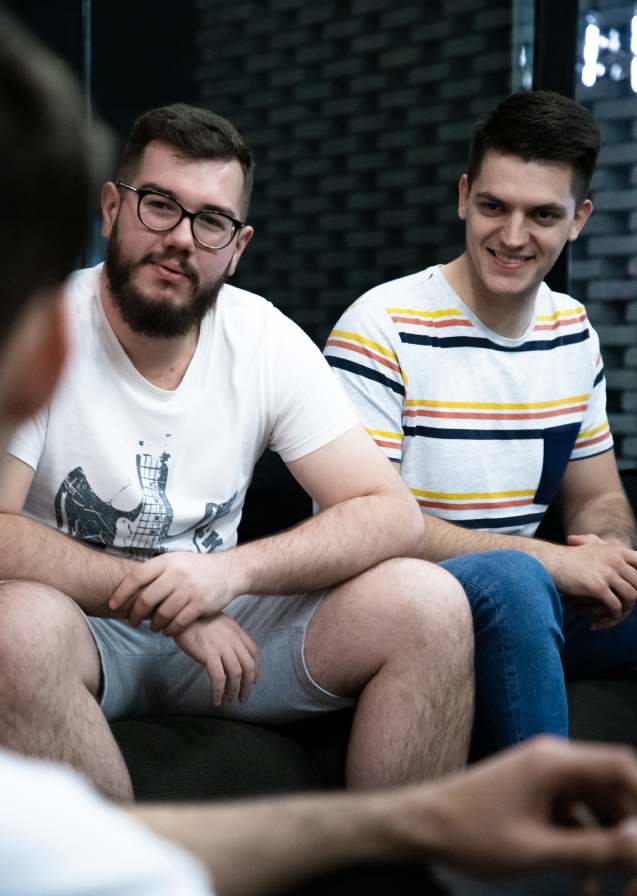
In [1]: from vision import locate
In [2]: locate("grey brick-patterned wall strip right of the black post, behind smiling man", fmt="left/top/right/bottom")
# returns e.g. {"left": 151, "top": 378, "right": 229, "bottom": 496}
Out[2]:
{"left": 571, "top": 0, "right": 637, "bottom": 468}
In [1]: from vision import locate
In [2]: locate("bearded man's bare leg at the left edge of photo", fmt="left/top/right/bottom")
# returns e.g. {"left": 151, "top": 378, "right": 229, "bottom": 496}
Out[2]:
{"left": 0, "top": 582, "right": 133, "bottom": 801}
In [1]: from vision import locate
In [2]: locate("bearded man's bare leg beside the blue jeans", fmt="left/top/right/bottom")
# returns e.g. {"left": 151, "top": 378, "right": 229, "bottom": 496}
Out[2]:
{"left": 305, "top": 560, "right": 473, "bottom": 787}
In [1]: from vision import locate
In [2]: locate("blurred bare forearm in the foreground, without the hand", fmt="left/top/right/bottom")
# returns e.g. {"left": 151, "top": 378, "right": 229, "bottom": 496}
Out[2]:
{"left": 129, "top": 794, "right": 434, "bottom": 896}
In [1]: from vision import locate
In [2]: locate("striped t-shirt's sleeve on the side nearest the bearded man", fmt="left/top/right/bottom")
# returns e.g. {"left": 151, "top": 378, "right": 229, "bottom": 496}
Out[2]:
{"left": 324, "top": 297, "right": 407, "bottom": 462}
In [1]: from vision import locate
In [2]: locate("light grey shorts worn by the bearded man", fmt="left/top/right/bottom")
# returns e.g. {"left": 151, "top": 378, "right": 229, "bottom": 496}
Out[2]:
{"left": 87, "top": 591, "right": 356, "bottom": 725}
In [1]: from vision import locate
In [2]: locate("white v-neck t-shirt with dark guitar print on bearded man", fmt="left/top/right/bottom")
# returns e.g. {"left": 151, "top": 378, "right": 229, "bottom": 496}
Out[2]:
{"left": 10, "top": 265, "right": 358, "bottom": 560}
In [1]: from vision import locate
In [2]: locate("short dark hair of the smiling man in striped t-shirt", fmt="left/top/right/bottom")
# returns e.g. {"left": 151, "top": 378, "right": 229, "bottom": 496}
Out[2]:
{"left": 467, "top": 90, "right": 601, "bottom": 205}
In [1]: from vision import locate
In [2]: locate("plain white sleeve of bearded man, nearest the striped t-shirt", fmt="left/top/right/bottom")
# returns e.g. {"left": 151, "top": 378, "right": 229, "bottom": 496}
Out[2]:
{"left": 268, "top": 312, "right": 359, "bottom": 463}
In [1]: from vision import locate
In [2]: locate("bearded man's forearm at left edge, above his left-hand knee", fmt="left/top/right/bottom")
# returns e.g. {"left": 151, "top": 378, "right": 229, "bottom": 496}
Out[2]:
{"left": 0, "top": 514, "right": 136, "bottom": 616}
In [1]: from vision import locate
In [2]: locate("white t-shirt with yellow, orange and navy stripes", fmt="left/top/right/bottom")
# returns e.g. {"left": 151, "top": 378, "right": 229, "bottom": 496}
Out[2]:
{"left": 325, "top": 267, "right": 613, "bottom": 536}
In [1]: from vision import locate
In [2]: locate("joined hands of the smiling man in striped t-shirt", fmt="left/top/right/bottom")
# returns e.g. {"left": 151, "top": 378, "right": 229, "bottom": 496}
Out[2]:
{"left": 550, "top": 535, "right": 637, "bottom": 631}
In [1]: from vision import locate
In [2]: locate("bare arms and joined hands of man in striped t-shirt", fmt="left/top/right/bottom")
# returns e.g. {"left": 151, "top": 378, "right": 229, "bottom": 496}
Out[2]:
{"left": 414, "top": 451, "right": 637, "bottom": 628}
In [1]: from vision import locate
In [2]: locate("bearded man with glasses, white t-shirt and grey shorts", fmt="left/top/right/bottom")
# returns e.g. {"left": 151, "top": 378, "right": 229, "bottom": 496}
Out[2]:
{"left": 0, "top": 105, "right": 473, "bottom": 800}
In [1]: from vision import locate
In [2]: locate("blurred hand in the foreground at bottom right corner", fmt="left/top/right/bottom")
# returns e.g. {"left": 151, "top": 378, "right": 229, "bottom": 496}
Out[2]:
{"left": 396, "top": 738, "right": 637, "bottom": 877}
